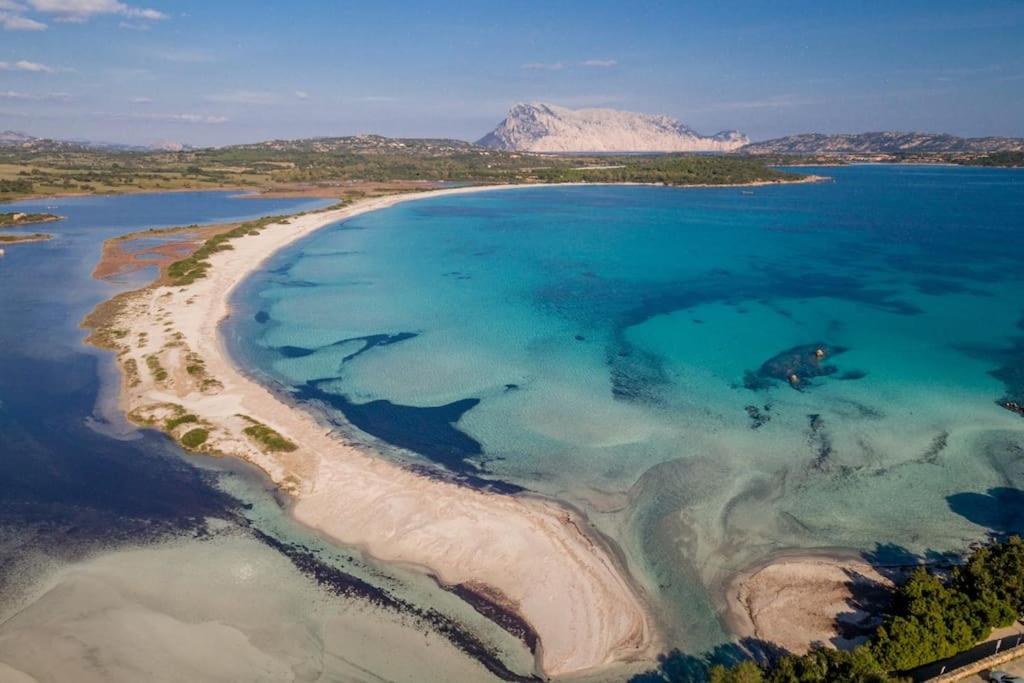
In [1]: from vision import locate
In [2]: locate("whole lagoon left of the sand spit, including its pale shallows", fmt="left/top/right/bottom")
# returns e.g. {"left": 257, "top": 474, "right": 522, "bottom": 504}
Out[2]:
{"left": 0, "top": 193, "right": 532, "bottom": 681}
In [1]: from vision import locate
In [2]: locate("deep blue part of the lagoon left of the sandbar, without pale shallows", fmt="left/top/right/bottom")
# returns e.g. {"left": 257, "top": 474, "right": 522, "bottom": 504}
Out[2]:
{"left": 0, "top": 193, "right": 324, "bottom": 573}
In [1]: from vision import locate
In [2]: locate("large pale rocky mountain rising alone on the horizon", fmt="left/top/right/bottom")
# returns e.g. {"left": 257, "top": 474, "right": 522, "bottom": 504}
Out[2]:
{"left": 477, "top": 103, "right": 750, "bottom": 152}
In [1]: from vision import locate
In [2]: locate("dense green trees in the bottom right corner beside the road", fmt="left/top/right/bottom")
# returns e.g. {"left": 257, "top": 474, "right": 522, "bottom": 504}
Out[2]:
{"left": 711, "top": 536, "right": 1024, "bottom": 683}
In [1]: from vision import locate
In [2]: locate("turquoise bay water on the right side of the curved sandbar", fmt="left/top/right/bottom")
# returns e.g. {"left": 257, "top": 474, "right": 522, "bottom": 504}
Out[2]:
{"left": 227, "top": 166, "right": 1024, "bottom": 651}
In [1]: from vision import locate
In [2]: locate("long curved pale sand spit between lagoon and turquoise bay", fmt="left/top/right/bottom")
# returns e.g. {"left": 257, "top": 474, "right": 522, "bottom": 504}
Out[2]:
{"left": 89, "top": 185, "right": 658, "bottom": 676}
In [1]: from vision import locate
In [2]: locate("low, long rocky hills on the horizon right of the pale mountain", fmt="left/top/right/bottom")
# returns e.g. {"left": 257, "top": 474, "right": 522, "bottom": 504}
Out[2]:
{"left": 739, "top": 131, "right": 1024, "bottom": 155}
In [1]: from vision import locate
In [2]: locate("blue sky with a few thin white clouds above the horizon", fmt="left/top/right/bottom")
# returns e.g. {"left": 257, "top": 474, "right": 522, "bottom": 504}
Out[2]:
{"left": 0, "top": 0, "right": 1024, "bottom": 145}
